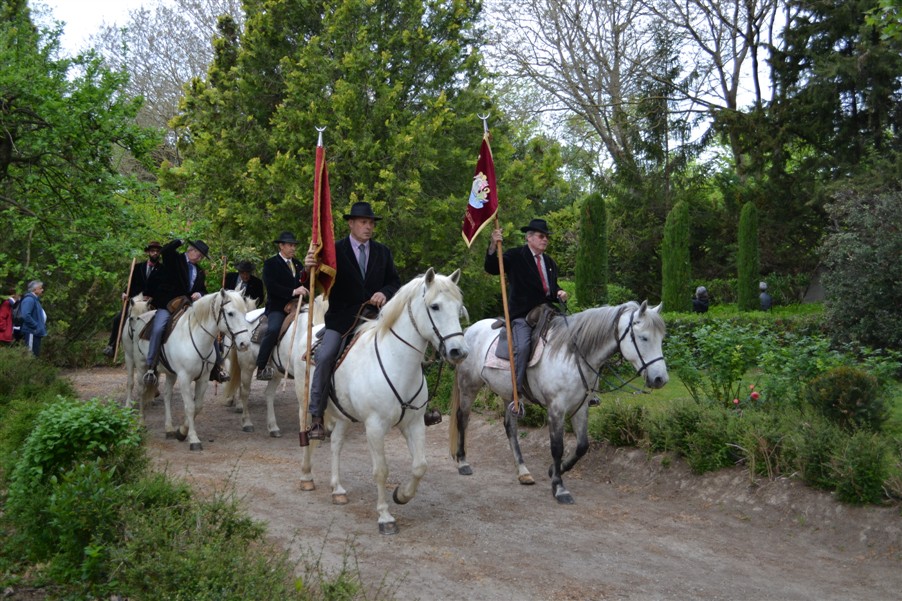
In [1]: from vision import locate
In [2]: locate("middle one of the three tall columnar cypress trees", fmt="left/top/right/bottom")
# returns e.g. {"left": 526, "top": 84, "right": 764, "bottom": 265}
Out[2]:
{"left": 661, "top": 202, "right": 692, "bottom": 311}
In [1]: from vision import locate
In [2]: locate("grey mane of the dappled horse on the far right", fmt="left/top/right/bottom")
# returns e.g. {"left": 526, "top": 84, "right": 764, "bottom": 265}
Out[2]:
{"left": 546, "top": 301, "right": 665, "bottom": 355}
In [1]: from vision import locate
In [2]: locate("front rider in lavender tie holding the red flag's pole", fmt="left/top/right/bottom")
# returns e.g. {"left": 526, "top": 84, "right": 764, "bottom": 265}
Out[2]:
{"left": 305, "top": 202, "right": 401, "bottom": 440}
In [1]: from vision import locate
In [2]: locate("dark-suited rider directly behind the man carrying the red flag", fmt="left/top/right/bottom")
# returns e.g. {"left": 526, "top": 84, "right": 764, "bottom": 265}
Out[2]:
{"left": 257, "top": 232, "right": 307, "bottom": 380}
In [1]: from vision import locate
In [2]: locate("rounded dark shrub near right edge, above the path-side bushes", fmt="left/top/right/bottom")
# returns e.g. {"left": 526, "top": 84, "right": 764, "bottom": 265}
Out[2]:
{"left": 806, "top": 366, "right": 887, "bottom": 432}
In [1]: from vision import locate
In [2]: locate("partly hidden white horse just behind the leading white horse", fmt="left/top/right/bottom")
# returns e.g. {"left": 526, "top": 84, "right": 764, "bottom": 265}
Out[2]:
{"left": 223, "top": 295, "right": 326, "bottom": 438}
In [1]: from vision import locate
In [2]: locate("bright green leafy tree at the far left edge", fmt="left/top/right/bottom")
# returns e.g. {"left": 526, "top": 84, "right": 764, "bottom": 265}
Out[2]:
{"left": 0, "top": 1, "right": 157, "bottom": 354}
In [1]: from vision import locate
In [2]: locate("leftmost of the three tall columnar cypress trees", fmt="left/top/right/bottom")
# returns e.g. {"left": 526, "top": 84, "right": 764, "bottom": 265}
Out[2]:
{"left": 576, "top": 192, "right": 608, "bottom": 307}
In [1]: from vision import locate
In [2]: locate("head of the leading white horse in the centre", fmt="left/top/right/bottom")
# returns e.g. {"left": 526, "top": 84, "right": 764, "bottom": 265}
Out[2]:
{"left": 409, "top": 267, "right": 469, "bottom": 364}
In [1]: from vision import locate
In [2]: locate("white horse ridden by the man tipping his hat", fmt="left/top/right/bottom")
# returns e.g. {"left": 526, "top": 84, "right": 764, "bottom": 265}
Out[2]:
{"left": 138, "top": 290, "right": 251, "bottom": 451}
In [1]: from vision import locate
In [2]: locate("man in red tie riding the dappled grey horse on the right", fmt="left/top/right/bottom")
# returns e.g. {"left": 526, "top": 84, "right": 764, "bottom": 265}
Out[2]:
{"left": 484, "top": 219, "right": 567, "bottom": 397}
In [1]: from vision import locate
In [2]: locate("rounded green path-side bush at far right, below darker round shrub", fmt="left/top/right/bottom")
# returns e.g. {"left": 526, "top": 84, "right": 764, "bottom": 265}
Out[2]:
{"left": 831, "top": 431, "right": 890, "bottom": 505}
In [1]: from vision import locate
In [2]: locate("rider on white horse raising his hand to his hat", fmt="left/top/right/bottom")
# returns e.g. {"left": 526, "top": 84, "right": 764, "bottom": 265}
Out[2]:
{"left": 144, "top": 238, "right": 228, "bottom": 386}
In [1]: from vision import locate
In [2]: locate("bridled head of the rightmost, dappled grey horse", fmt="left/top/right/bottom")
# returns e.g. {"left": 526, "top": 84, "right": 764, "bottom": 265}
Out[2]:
{"left": 617, "top": 301, "right": 669, "bottom": 388}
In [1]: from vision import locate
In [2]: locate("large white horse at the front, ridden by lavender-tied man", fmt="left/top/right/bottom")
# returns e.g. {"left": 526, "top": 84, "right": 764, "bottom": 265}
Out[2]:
{"left": 294, "top": 268, "right": 468, "bottom": 534}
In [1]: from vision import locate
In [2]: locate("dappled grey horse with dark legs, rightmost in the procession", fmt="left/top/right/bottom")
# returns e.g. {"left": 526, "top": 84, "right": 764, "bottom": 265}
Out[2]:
{"left": 449, "top": 302, "right": 668, "bottom": 504}
